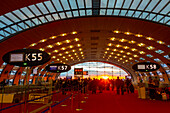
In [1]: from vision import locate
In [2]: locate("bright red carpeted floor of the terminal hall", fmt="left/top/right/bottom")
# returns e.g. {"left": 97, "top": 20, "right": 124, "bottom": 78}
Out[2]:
{"left": 1, "top": 91, "right": 170, "bottom": 113}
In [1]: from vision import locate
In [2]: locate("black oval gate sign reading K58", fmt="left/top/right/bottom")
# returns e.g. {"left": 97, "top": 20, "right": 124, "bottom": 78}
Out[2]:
{"left": 132, "top": 62, "right": 160, "bottom": 72}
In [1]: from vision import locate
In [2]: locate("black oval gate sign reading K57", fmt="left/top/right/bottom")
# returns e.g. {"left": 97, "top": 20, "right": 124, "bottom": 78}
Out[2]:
{"left": 46, "top": 63, "right": 71, "bottom": 73}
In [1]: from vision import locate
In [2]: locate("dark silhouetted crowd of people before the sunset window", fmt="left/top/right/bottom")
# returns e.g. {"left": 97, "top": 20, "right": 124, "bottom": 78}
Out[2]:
{"left": 53, "top": 77, "right": 134, "bottom": 95}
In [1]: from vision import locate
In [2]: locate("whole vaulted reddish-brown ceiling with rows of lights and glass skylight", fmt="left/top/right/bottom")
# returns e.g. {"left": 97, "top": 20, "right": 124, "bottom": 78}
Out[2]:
{"left": 0, "top": 0, "right": 170, "bottom": 81}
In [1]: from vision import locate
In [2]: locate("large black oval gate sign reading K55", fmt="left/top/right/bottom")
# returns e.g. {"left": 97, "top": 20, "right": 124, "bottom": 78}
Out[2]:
{"left": 2, "top": 49, "right": 50, "bottom": 67}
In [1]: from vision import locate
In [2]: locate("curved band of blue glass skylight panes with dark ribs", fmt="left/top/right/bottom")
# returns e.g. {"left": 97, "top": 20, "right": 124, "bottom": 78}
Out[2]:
{"left": 0, "top": 0, "right": 170, "bottom": 41}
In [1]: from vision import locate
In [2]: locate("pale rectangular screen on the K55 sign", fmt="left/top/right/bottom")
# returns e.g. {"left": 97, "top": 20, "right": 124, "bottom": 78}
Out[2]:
{"left": 10, "top": 53, "right": 24, "bottom": 62}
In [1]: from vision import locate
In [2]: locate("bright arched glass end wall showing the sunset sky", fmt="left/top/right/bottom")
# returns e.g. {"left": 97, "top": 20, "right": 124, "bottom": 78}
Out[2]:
{"left": 60, "top": 62, "right": 128, "bottom": 79}
